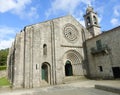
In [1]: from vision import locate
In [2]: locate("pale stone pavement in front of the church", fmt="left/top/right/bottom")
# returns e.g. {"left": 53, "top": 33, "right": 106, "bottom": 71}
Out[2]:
{"left": 0, "top": 80, "right": 120, "bottom": 95}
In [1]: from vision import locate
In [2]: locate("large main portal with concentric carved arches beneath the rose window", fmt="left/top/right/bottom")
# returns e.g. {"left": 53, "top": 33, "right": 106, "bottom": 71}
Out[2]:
{"left": 63, "top": 50, "right": 83, "bottom": 76}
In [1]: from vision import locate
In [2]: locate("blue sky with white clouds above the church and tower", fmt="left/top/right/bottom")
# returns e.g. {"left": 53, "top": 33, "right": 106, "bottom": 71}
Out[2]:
{"left": 0, "top": 0, "right": 120, "bottom": 49}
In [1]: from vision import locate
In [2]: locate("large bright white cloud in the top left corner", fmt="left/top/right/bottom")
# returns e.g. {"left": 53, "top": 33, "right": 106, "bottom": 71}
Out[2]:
{"left": 0, "top": 0, "right": 39, "bottom": 19}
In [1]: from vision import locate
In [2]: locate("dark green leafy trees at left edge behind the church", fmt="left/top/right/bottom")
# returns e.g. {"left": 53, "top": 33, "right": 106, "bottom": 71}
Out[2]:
{"left": 0, "top": 49, "right": 9, "bottom": 66}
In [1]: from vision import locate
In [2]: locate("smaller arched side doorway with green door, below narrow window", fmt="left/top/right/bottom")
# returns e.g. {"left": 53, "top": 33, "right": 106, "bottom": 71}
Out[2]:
{"left": 41, "top": 63, "right": 50, "bottom": 83}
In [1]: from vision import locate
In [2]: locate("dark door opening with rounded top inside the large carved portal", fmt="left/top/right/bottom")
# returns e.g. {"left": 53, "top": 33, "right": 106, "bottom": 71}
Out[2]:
{"left": 65, "top": 60, "right": 73, "bottom": 76}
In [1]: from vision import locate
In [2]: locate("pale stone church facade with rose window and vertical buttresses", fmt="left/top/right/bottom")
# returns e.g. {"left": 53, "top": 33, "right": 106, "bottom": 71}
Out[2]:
{"left": 8, "top": 16, "right": 88, "bottom": 88}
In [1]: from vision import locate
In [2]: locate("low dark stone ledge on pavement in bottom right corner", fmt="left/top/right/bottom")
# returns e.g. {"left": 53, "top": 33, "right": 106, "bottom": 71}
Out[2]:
{"left": 95, "top": 85, "right": 120, "bottom": 94}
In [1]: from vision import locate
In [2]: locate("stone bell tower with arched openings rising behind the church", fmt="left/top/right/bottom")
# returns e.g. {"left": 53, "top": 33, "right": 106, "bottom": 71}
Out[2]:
{"left": 84, "top": 6, "right": 101, "bottom": 37}
